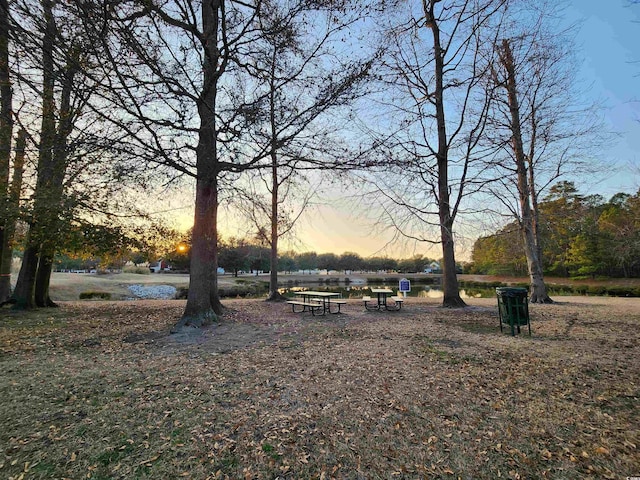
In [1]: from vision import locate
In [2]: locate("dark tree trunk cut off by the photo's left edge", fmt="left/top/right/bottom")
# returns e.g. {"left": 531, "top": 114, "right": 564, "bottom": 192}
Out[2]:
{"left": 0, "top": 0, "right": 13, "bottom": 304}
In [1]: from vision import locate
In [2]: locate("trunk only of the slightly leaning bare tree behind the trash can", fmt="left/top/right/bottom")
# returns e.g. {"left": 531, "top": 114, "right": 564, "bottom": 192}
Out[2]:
{"left": 500, "top": 40, "right": 552, "bottom": 303}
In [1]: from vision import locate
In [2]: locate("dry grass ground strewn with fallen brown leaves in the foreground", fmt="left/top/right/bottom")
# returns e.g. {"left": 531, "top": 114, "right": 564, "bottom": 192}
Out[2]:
{"left": 0, "top": 297, "right": 640, "bottom": 479}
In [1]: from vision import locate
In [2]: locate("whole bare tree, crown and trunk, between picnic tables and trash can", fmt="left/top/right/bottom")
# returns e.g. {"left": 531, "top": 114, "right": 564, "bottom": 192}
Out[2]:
{"left": 356, "top": 0, "right": 505, "bottom": 307}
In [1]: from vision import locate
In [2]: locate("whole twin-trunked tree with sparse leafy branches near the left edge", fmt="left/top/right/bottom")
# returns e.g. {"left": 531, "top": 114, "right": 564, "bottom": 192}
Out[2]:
{"left": 3, "top": 0, "right": 161, "bottom": 308}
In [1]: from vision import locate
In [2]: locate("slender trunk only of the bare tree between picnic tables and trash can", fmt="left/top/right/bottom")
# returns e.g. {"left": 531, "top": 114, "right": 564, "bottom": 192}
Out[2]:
{"left": 423, "top": 1, "right": 466, "bottom": 308}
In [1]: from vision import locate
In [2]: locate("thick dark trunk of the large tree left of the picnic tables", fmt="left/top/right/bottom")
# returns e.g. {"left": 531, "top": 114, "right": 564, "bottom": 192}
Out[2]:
{"left": 173, "top": 0, "right": 224, "bottom": 332}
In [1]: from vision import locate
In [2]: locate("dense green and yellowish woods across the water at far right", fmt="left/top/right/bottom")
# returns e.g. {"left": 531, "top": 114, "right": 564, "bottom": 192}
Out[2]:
{"left": 469, "top": 182, "right": 640, "bottom": 278}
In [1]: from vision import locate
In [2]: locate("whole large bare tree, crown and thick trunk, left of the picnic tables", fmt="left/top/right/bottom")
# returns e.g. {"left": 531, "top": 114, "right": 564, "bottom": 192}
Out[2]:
{"left": 86, "top": 0, "right": 262, "bottom": 330}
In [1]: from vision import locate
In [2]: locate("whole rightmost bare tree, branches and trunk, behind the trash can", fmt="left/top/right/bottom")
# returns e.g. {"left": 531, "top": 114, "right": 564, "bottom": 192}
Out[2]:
{"left": 485, "top": 2, "right": 598, "bottom": 303}
